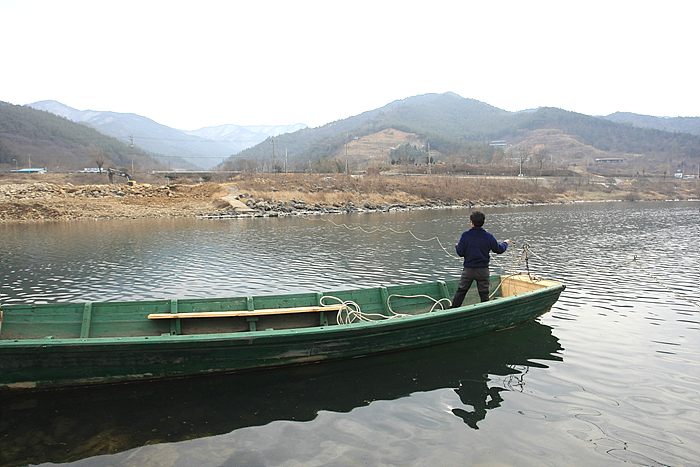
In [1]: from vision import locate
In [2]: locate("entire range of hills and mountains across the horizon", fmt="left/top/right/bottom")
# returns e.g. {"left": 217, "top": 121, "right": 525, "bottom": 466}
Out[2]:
{"left": 0, "top": 92, "right": 700, "bottom": 173}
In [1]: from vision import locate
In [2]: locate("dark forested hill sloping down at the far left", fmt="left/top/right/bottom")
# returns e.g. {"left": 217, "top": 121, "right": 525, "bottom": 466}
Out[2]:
{"left": 0, "top": 102, "right": 163, "bottom": 172}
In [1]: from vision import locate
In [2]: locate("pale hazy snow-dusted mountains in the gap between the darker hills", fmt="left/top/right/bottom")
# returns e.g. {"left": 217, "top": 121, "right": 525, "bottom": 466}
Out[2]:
{"left": 28, "top": 100, "right": 306, "bottom": 169}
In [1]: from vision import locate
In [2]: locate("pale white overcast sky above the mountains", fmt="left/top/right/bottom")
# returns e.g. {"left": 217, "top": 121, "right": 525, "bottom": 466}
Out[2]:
{"left": 0, "top": 0, "right": 700, "bottom": 130}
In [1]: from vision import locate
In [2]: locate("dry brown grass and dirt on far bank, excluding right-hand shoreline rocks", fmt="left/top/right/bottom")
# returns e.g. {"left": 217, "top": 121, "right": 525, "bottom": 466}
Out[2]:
{"left": 0, "top": 174, "right": 700, "bottom": 222}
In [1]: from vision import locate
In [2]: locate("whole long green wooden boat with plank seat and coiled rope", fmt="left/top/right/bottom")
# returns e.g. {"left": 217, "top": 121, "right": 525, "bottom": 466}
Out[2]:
{"left": 0, "top": 275, "right": 564, "bottom": 391}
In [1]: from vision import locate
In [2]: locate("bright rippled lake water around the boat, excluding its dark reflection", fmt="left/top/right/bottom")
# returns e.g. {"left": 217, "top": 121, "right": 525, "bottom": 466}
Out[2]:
{"left": 0, "top": 203, "right": 700, "bottom": 467}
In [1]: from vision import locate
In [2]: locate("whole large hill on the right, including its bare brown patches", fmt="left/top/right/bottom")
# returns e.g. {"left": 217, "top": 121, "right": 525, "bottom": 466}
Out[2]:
{"left": 226, "top": 92, "right": 700, "bottom": 173}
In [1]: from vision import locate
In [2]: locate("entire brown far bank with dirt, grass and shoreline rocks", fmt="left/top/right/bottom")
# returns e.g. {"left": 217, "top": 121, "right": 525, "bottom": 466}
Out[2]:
{"left": 0, "top": 174, "right": 700, "bottom": 222}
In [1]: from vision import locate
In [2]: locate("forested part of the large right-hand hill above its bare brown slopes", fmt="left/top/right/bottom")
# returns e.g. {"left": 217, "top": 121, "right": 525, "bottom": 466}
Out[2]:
{"left": 229, "top": 93, "right": 700, "bottom": 175}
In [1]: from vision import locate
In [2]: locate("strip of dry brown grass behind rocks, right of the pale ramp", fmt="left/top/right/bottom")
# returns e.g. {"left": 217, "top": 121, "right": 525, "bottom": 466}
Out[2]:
{"left": 231, "top": 174, "right": 700, "bottom": 204}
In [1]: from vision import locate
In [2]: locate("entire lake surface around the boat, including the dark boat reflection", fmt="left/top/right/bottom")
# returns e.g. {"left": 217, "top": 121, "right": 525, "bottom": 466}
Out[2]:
{"left": 0, "top": 202, "right": 700, "bottom": 467}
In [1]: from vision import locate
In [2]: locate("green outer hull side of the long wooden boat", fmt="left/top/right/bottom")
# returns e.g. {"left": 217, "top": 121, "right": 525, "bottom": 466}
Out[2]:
{"left": 0, "top": 281, "right": 564, "bottom": 390}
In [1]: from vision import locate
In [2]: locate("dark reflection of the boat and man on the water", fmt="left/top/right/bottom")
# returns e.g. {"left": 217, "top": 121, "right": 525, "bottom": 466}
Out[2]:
{"left": 0, "top": 321, "right": 562, "bottom": 467}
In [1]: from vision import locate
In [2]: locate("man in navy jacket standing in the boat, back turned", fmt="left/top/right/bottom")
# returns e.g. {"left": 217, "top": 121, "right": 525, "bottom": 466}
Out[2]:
{"left": 452, "top": 211, "right": 510, "bottom": 308}
